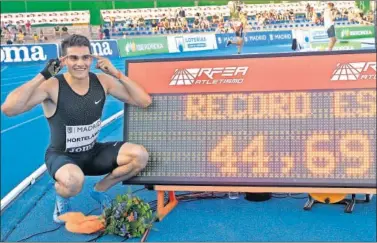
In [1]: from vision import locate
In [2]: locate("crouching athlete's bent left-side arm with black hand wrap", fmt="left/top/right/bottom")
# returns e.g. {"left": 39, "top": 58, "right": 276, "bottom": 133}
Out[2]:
{"left": 1, "top": 58, "right": 62, "bottom": 116}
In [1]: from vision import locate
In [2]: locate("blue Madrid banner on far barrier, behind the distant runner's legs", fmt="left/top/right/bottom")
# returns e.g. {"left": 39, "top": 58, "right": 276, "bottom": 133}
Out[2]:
{"left": 216, "top": 30, "right": 292, "bottom": 49}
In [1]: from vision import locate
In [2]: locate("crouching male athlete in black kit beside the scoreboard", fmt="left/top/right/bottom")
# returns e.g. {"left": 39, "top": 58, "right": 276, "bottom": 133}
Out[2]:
{"left": 1, "top": 35, "right": 151, "bottom": 223}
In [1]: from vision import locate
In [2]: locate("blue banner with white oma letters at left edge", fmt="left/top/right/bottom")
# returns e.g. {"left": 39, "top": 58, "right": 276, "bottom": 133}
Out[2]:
{"left": 0, "top": 44, "right": 59, "bottom": 63}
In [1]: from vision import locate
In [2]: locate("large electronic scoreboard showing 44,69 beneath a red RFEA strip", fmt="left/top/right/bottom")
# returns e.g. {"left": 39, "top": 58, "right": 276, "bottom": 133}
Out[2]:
{"left": 124, "top": 51, "right": 376, "bottom": 188}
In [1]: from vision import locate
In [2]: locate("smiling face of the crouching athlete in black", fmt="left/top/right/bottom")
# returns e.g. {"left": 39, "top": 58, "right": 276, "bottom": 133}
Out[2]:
{"left": 64, "top": 46, "right": 92, "bottom": 79}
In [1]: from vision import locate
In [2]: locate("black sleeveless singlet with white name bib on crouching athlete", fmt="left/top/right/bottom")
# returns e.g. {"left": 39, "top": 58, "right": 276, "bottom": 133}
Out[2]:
{"left": 47, "top": 73, "right": 106, "bottom": 153}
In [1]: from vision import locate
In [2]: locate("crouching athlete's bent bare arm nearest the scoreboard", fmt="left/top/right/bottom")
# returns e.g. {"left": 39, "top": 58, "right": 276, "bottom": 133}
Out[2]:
{"left": 93, "top": 55, "right": 152, "bottom": 108}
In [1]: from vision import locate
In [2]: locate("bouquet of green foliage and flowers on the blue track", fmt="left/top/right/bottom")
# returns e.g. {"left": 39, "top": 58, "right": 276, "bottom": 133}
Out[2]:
{"left": 102, "top": 193, "right": 154, "bottom": 238}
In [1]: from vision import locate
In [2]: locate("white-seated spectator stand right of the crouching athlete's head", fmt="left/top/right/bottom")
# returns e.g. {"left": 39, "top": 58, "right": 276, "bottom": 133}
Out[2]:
{"left": 97, "top": 1, "right": 370, "bottom": 38}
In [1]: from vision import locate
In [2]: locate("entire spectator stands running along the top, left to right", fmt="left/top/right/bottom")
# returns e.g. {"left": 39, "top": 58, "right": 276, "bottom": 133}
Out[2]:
{"left": 1, "top": 1, "right": 373, "bottom": 43}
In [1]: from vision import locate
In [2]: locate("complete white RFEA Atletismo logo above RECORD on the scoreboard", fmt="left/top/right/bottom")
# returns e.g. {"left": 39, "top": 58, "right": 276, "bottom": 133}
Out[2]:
{"left": 169, "top": 67, "right": 249, "bottom": 86}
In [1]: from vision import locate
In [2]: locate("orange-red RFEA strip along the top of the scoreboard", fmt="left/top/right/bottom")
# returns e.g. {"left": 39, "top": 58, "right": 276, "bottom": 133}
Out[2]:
{"left": 128, "top": 53, "right": 376, "bottom": 94}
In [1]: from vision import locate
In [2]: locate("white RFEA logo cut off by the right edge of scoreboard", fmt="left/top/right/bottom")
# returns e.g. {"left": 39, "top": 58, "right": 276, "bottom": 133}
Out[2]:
{"left": 331, "top": 62, "right": 376, "bottom": 81}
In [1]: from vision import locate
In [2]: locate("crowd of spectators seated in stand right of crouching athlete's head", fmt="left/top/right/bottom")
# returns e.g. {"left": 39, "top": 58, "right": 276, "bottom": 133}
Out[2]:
{"left": 98, "top": 4, "right": 374, "bottom": 39}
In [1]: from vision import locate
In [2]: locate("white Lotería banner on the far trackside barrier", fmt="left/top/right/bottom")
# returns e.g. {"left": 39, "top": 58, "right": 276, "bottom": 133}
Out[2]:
{"left": 168, "top": 34, "right": 217, "bottom": 53}
